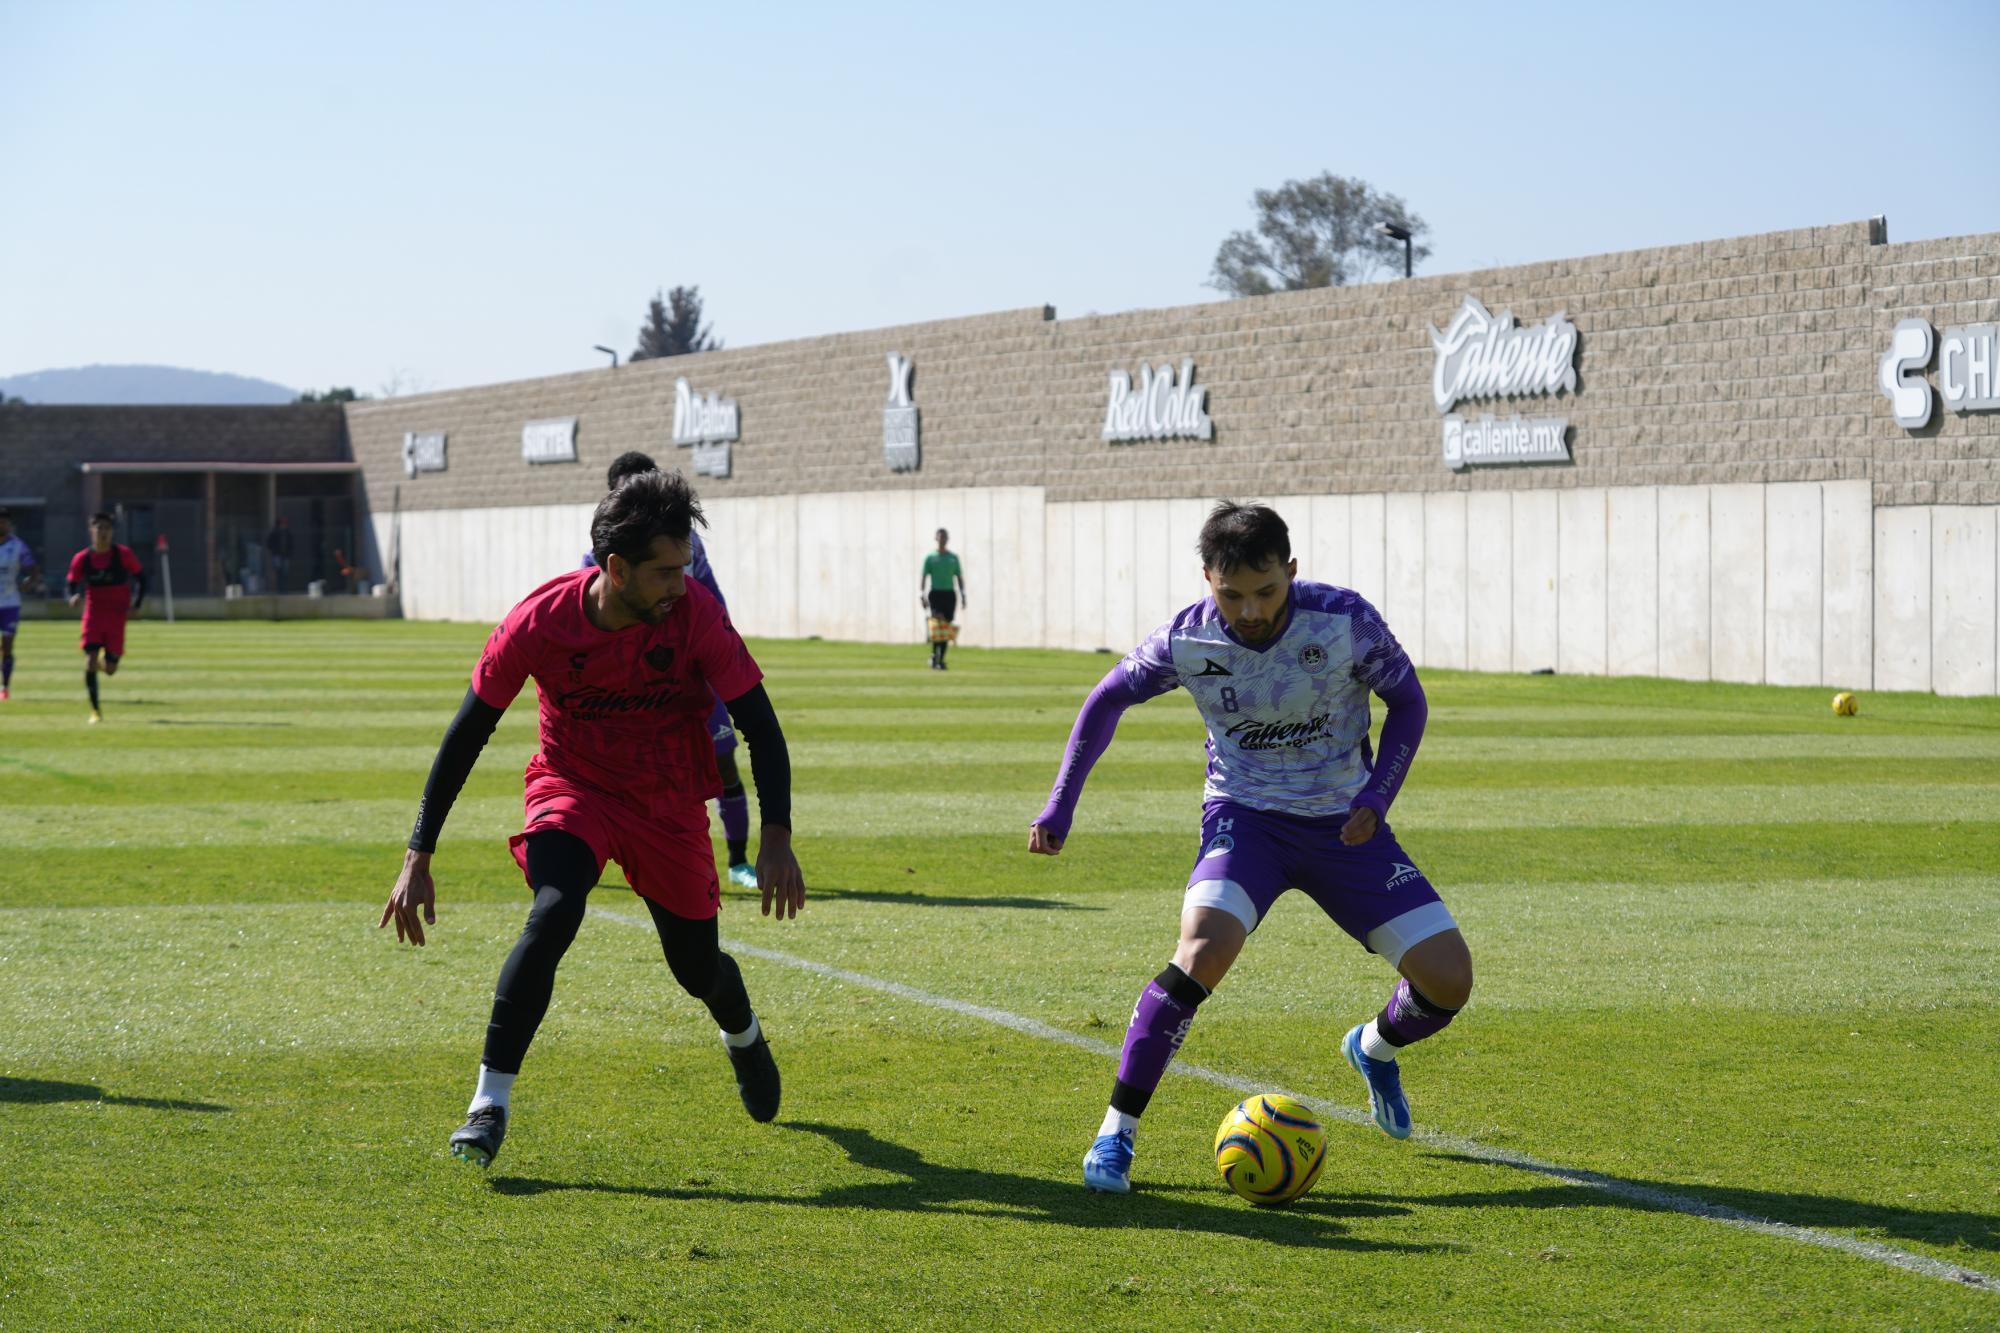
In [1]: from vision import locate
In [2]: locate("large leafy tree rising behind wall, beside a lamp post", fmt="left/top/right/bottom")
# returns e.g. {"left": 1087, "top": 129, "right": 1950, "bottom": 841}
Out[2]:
{"left": 1208, "top": 172, "right": 1430, "bottom": 296}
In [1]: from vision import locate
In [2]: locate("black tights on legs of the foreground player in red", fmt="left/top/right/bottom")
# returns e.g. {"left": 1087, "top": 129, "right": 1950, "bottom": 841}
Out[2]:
{"left": 482, "top": 831, "right": 750, "bottom": 1073}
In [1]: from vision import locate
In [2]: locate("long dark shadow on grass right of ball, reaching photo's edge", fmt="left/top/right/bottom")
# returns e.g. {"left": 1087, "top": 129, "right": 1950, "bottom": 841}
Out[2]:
{"left": 1404, "top": 1153, "right": 2000, "bottom": 1253}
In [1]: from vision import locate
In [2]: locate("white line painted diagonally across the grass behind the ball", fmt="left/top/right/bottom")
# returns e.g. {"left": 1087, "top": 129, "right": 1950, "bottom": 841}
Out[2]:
{"left": 590, "top": 907, "right": 2000, "bottom": 1293}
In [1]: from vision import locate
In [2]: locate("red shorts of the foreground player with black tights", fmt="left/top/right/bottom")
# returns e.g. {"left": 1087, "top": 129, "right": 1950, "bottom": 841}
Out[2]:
{"left": 508, "top": 773, "right": 722, "bottom": 921}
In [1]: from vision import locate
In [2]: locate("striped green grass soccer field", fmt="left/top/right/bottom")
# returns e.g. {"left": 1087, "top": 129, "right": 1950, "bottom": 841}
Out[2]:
{"left": 0, "top": 622, "right": 2000, "bottom": 1329}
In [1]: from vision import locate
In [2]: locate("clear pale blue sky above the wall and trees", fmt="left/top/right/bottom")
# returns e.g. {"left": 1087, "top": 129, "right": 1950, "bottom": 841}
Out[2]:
{"left": 0, "top": 0, "right": 2000, "bottom": 392}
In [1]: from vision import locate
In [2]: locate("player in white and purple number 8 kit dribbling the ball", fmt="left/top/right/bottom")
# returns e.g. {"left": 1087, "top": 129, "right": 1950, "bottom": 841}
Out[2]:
{"left": 1028, "top": 502, "right": 1472, "bottom": 1193}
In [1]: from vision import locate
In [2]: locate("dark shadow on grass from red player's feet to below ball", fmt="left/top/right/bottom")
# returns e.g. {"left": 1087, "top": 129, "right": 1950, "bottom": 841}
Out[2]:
{"left": 492, "top": 1121, "right": 1440, "bottom": 1253}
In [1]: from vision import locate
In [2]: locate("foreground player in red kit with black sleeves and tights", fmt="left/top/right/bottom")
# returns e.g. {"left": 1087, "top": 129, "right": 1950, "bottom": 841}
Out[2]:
{"left": 378, "top": 472, "right": 806, "bottom": 1167}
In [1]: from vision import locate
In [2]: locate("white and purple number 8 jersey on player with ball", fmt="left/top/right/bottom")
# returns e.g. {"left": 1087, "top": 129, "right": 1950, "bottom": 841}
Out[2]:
{"left": 1120, "top": 580, "right": 1410, "bottom": 817}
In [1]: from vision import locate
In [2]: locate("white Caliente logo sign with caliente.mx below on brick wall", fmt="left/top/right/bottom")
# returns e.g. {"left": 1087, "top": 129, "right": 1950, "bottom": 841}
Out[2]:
{"left": 1430, "top": 296, "right": 1576, "bottom": 468}
